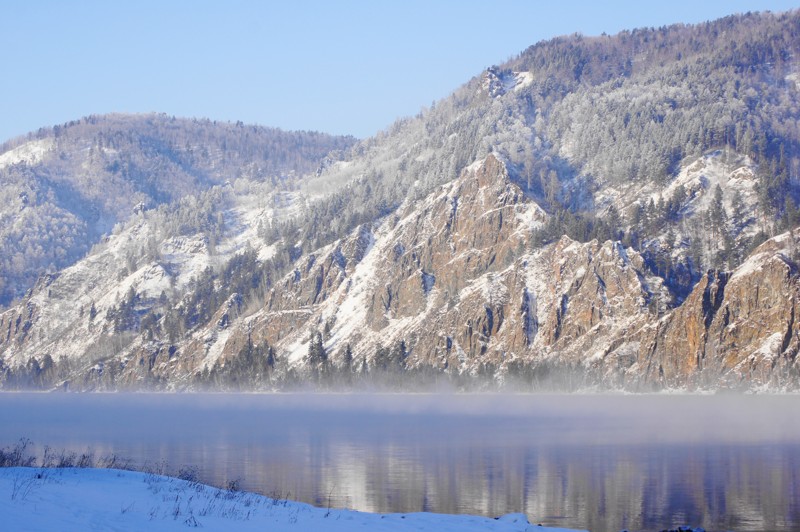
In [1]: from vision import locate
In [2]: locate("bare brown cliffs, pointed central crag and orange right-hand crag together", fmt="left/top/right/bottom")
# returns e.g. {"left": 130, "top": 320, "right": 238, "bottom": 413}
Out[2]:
{"left": 191, "top": 156, "right": 798, "bottom": 390}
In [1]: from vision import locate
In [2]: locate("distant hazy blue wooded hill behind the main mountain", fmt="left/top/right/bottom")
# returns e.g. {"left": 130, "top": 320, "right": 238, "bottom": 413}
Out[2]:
{"left": 0, "top": 115, "right": 353, "bottom": 305}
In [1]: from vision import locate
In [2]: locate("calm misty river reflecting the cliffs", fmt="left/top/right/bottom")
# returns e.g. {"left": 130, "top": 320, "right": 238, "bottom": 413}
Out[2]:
{"left": 0, "top": 394, "right": 800, "bottom": 530}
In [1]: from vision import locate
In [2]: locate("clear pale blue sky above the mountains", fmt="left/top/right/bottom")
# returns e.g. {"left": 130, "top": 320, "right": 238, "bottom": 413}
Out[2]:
{"left": 0, "top": 0, "right": 798, "bottom": 142}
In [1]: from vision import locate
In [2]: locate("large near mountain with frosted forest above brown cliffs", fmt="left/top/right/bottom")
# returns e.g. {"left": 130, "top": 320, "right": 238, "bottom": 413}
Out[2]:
{"left": 0, "top": 11, "right": 800, "bottom": 391}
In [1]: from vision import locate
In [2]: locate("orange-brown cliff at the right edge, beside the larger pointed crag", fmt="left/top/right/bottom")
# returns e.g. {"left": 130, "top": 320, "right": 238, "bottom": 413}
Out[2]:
{"left": 641, "top": 233, "right": 800, "bottom": 389}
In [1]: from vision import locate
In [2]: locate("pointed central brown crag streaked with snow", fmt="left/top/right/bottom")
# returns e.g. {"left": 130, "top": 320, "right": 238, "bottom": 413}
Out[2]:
{"left": 205, "top": 156, "right": 671, "bottom": 385}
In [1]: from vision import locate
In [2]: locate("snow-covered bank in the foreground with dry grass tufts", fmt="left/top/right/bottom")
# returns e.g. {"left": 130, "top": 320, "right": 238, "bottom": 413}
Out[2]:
{"left": 0, "top": 467, "right": 584, "bottom": 532}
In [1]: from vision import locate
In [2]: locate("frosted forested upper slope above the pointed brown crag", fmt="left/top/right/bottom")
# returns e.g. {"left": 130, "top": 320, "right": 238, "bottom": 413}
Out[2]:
{"left": 284, "top": 12, "right": 800, "bottom": 296}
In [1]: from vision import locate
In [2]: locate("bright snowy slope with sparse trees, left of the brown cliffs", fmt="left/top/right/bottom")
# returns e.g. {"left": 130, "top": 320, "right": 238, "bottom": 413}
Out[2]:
{"left": 0, "top": 182, "right": 294, "bottom": 382}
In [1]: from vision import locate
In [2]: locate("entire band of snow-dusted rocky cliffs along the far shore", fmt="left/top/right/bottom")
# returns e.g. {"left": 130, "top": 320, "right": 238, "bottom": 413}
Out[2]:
{"left": 0, "top": 155, "right": 800, "bottom": 391}
